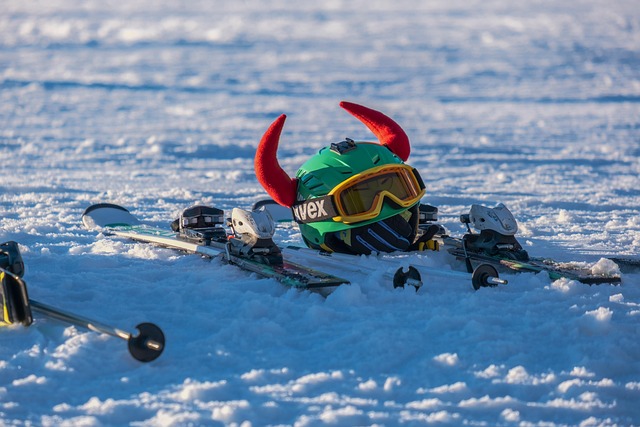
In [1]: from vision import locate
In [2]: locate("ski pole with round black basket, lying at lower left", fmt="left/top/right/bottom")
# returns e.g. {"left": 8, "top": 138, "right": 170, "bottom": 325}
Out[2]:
{"left": 29, "top": 299, "right": 165, "bottom": 362}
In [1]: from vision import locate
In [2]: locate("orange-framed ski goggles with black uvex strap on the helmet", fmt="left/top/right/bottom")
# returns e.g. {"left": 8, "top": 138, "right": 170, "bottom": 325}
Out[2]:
{"left": 292, "top": 164, "right": 425, "bottom": 224}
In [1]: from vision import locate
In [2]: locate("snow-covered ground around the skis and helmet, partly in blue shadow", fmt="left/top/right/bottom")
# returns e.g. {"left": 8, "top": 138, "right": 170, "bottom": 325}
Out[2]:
{"left": 0, "top": 0, "right": 640, "bottom": 426}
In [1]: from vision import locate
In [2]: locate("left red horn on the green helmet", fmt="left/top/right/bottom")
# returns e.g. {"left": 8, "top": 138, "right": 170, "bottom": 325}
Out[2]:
{"left": 254, "top": 114, "right": 298, "bottom": 208}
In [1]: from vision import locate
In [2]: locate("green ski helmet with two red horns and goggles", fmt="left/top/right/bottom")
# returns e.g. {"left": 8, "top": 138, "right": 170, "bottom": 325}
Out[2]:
{"left": 256, "top": 102, "right": 424, "bottom": 253}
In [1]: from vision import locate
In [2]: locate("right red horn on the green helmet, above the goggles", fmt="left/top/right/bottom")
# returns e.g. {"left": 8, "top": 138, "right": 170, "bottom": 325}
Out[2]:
{"left": 340, "top": 101, "right": 411, "bottom": 162}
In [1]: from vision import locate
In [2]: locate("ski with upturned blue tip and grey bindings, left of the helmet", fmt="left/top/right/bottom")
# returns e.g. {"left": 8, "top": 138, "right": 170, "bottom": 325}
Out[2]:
{"left": 82, "top": 203, "right": 349, "bottom": 292}
